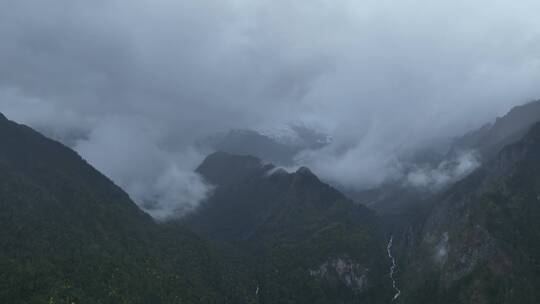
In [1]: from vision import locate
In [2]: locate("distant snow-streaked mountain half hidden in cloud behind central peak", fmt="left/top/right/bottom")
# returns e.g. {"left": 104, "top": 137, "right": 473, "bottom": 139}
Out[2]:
{"left": 197, "top": 126, "right": 329, "bottom": 166}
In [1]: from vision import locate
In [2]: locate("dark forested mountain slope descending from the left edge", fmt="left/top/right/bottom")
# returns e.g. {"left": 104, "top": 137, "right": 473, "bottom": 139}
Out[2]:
{"left": 0, "top": 114, "right": 255, "bottom": 303}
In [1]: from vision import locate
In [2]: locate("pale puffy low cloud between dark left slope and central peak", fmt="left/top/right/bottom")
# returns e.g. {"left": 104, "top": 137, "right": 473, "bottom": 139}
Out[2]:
{"left": 74, "top": 117, "right": 212, "bottom": 219}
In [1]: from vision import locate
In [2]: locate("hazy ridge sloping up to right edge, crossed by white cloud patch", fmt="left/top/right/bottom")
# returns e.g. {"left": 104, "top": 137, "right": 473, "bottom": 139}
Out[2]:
{"left": 352, "top": 100, "right": 540, "bottom": 227}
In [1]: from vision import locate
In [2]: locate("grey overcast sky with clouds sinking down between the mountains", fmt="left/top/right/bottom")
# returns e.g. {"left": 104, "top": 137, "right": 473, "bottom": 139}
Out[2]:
{"left": 0, "top": 0, "right": 540, "bottom": 216}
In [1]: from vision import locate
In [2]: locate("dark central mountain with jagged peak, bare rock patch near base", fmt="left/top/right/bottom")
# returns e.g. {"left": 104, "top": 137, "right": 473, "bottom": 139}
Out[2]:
{"left": 183, "top": 152, "right": 392, "bottom": 303}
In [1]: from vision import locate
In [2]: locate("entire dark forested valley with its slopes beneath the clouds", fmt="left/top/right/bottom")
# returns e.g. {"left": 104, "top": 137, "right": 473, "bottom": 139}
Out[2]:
{"left": 0, "top": 99, "right": 540, "bottom": 304}
